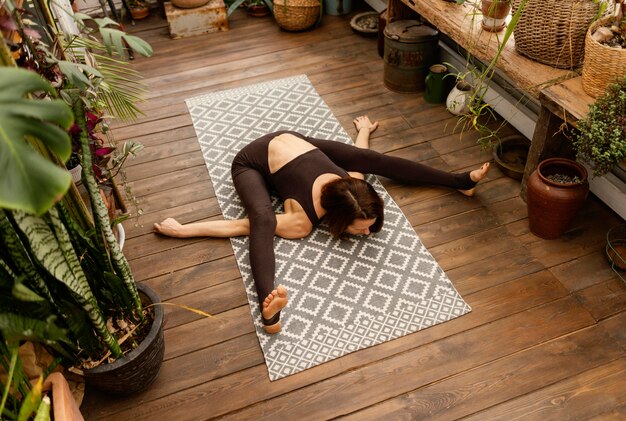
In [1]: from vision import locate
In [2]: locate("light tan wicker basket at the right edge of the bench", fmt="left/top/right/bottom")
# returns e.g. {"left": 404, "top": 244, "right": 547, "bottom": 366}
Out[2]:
{"left": 583, "top": 16, "right": 626, "bottom": 98}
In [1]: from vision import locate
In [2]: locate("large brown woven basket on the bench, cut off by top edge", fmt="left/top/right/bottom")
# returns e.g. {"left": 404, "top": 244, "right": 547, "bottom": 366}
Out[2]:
{"left": 513, "top": 0, "right": 599, "bottom": 68}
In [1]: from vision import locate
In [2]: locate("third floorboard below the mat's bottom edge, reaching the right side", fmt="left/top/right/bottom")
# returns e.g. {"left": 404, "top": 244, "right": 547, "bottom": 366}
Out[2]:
{"left": 346, "top": 325, "right": 626, "bottom": 421}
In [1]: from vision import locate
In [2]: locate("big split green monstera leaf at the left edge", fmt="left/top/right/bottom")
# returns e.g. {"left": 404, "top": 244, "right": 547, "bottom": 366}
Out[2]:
{"left": 0, "top": 67, "right": 74, "bottom": 215}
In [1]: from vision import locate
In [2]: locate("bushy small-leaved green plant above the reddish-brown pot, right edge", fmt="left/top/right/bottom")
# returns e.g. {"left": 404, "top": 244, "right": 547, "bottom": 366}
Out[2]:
{"left": 573, "top": 76, "right": 626, "bottom": 176}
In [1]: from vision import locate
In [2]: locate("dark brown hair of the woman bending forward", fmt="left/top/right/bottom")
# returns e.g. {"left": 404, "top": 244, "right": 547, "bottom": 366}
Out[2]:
{"left": 322, "top": 177, "right": 385, "bottom": 238}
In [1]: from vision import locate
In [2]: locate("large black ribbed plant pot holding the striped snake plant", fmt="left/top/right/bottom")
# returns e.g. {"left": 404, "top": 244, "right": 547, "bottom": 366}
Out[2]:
{"left": 84, "top": 284, "right": 165, "bottom": 395}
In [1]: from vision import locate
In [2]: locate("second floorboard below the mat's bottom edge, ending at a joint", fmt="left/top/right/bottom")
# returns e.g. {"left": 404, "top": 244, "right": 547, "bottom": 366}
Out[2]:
{"left": 186, "top": 298, "right": 596, "bottom": 420}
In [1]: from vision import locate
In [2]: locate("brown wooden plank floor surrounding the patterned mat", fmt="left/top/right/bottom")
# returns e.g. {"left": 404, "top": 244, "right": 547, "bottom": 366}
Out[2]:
{"left": 82, "top": 9, "right": 626, "bottom": 421}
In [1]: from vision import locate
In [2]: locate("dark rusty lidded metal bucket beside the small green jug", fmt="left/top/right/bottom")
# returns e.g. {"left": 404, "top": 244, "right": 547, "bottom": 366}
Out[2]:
{"left": 384, "top": 20, "right": 439, "bottom": 92}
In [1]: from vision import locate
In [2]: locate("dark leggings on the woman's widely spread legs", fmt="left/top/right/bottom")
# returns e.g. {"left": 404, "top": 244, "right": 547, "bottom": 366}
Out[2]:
{"left": 231, "top": 132, "right": 476, "bottom": 316}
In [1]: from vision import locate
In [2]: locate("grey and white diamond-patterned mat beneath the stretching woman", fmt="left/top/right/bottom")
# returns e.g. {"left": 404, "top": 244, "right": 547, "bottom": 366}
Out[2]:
{"left": 186, "top": 75, "right": 471, "bottom": 380}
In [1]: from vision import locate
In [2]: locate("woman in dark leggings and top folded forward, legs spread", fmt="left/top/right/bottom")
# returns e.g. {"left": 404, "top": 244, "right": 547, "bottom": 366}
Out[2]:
{"left": 154, "top": 116, "right": 489, "bottom": 333}
